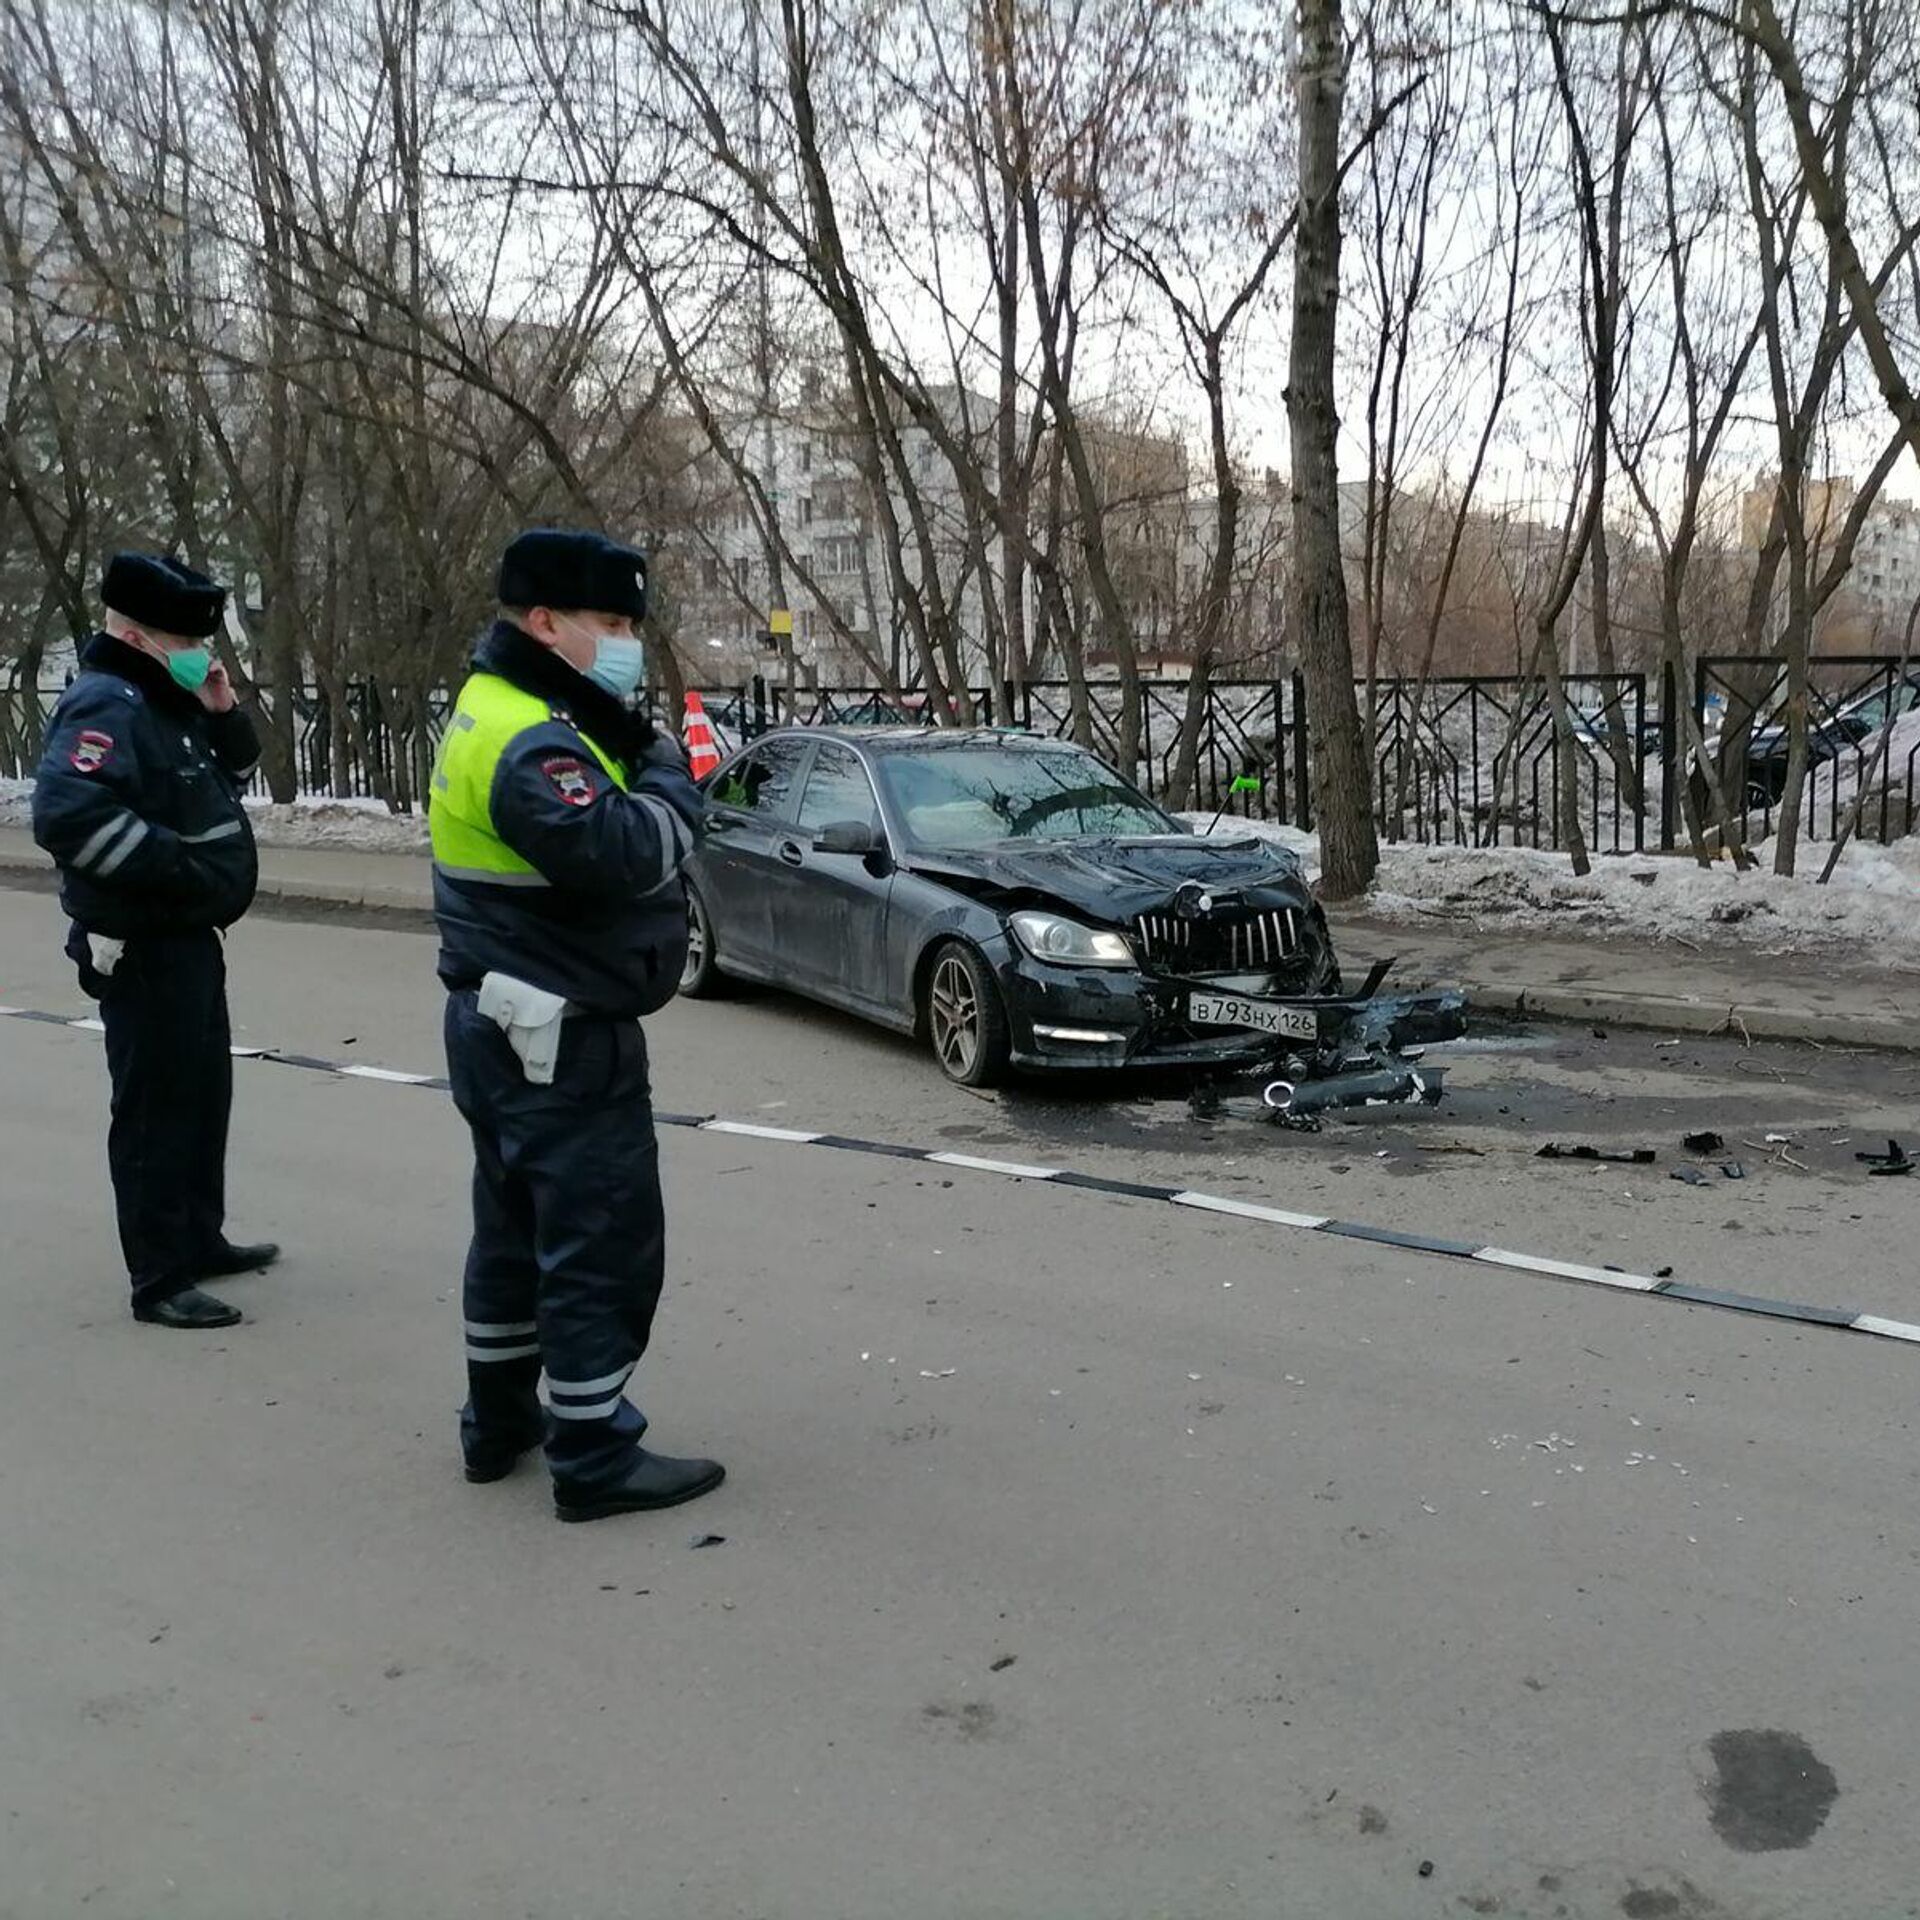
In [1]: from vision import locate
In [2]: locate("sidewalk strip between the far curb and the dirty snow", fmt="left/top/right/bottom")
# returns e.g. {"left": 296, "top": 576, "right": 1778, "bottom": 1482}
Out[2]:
{"left": 0, "top": 828, "right": 1920, "bottom": 1052}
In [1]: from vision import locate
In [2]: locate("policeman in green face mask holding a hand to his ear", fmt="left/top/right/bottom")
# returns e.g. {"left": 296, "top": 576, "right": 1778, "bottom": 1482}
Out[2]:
{"left": 33, "top": 553, "right": 280, "bottom": 1331}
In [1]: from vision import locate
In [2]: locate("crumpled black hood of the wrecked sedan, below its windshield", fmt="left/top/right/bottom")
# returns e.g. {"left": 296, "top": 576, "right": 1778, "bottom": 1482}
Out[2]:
{"left": 906, "top": 833, "right": 1308, "bottom": 920}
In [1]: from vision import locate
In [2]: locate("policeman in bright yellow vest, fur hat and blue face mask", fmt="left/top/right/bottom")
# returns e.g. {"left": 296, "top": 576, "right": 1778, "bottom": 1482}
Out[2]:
{"left": 428, "top": 530, "right": 724, "bottom": 1521}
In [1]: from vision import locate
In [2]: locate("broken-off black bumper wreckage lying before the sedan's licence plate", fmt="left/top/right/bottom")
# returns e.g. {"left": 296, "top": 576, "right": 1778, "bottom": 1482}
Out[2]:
{"left": 1167, "top": 960, "right": 1467, "bottom": 1133}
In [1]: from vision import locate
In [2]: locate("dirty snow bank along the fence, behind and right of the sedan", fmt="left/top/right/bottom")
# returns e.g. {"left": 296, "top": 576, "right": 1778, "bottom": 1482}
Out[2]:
{"left": 1185, "top": 814, "right": 1920, "bottom": 958}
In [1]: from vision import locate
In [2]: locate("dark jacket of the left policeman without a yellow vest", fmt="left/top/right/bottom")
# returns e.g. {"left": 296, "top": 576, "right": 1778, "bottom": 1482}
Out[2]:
{"left": 33, "top": 634, "right": 259, "bottom": 939}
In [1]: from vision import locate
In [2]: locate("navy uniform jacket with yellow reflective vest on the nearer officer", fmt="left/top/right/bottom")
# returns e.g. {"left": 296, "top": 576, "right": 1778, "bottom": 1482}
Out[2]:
{"left": 428, "top": 620, "right": 705, "bottom": 1020}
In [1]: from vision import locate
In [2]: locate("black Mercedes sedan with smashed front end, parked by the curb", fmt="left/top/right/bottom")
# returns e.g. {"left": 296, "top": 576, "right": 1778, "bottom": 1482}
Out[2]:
{"left": 682, "top": 728, "right": 1374, "bottom": 1087}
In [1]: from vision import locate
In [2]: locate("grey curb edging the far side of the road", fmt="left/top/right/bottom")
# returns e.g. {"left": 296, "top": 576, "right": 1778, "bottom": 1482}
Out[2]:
{"left": 0, "top": 852, "right": 1920, "bottom": 1054}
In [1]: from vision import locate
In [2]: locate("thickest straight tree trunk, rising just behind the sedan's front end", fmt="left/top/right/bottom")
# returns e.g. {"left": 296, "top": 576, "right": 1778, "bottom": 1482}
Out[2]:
{"left": 1286, "top": 0, "right": 1380, "bottom": 900}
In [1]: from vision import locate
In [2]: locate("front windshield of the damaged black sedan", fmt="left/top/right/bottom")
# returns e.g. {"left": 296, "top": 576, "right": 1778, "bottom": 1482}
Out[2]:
{"left": 879, "top": 747, "right": 1183, "bottom": 851}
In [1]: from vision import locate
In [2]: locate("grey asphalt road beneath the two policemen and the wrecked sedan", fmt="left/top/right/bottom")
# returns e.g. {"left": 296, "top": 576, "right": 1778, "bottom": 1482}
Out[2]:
{"left": 0, "top": 893, "right": 1920, "bottom": 1920}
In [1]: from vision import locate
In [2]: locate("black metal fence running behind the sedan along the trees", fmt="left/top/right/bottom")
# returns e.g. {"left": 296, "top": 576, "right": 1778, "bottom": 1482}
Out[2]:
{"left": 0, "top": 657, "right": 1920, "bottom": 852}
